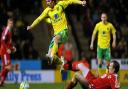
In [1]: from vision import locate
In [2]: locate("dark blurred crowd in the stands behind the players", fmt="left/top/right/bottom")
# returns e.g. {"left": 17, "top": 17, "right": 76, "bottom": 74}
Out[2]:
{"left": 0, "top": 0, "right": 128, "bottom": 59}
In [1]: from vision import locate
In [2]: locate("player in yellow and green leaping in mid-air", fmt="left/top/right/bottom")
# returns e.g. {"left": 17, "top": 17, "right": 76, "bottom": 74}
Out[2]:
{"left": 27, "top": 0, "right": 86, "bottom": 67}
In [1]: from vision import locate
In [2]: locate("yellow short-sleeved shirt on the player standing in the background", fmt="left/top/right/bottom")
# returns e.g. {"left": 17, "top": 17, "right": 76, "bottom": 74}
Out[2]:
{"left": 93, "top": 22, "right": 116, "bottom": 48}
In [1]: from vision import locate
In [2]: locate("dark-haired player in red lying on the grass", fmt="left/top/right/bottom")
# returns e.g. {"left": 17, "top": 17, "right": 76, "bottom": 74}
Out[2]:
{"left": 66, "top": 61, "right": 120, "bottom": 89}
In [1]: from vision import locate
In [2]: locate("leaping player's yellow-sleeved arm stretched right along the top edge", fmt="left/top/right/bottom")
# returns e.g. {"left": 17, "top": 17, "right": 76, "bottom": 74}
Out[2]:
{"left": 58, "top": 0, "right": 86, "bottom": 9}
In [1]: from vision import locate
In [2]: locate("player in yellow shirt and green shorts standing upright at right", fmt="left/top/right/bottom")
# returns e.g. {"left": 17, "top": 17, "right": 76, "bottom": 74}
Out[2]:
{"left": 90, "top": 13, "right": 116, "bottom": 75}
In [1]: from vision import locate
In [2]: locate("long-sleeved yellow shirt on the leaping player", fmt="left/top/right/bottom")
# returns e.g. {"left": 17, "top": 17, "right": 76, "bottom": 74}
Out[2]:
{"left": 31, "top": 0, "right": 81, "bottom": 35}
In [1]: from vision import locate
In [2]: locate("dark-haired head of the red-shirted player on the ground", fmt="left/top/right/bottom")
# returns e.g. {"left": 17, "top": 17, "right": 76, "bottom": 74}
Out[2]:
{"left": 109, "top": 61, "right": 120, "bottom": 73}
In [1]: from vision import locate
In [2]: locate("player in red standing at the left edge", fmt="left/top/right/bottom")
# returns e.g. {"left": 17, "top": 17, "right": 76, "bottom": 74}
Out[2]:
{"left": 0, "top": 18, "right": 16, "bottom": 85}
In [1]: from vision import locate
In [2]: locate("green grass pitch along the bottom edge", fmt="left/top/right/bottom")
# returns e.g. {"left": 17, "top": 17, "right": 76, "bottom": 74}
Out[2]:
{"left": 0, "top": 83, "right": 128, "bottom": 89}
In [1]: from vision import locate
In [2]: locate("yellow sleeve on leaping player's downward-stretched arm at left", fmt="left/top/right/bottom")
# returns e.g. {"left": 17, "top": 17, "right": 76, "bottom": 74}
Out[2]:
{"left": 31, "top": 7, "right": 49, "bottom": 28}
